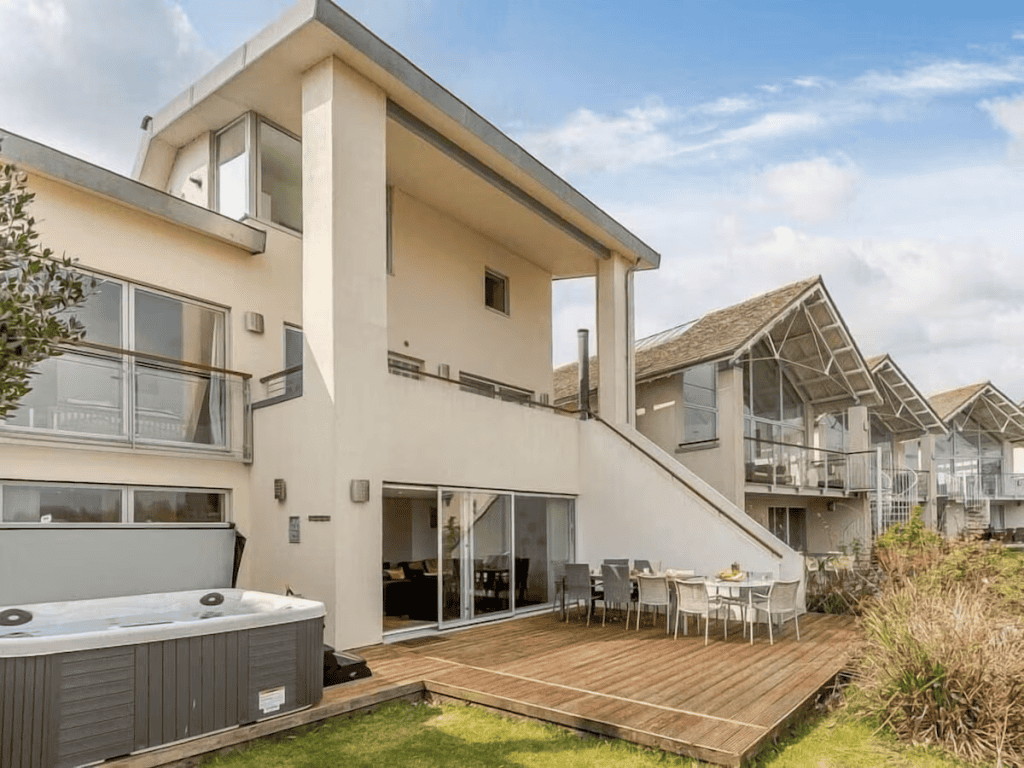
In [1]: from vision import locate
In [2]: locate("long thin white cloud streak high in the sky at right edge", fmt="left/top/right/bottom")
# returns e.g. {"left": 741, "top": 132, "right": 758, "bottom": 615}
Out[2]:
{"left": 853, "top": 58, "right": 1024, "bottom": 97}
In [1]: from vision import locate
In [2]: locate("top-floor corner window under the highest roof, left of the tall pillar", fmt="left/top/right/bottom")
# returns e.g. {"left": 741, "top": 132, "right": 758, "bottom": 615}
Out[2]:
{"left": 214, "top": 113, "right": 302, "bottom": 231}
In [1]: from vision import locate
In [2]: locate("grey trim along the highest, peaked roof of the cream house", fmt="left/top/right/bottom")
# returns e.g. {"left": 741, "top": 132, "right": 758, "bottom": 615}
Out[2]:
{"left": 134, "top": 0, "right": 662, "bottom": 269}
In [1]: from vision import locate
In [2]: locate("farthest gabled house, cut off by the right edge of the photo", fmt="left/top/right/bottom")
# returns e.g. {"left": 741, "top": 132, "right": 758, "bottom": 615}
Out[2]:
{"left": 907, "top": 381, "right": 1024, "bottom": 536}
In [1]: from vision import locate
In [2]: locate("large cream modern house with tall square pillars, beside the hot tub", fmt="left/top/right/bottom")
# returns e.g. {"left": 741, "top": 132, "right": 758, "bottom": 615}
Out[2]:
{"left": 0, "top": 0, "right": 802, "bottom": 647}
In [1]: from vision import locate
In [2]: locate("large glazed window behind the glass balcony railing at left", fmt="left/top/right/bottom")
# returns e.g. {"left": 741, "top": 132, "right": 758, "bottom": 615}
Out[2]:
{"left": 4, "top": 279, "right": 231, "bottom": 449}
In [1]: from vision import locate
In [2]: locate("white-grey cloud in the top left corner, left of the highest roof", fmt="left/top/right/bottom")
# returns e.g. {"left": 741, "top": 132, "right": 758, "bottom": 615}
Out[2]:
{"left": 0, "top": 0, "right": 214, "bottom": 172}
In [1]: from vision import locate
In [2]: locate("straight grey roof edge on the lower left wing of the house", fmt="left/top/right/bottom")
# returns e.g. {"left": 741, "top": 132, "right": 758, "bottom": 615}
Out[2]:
{"left": 0, "top": 128, "right": 266, "bottom": 253}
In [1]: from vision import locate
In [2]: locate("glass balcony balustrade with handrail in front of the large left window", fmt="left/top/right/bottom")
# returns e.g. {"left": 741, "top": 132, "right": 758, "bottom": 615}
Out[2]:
{"left": 2, "top": 342, "right": 252, "bottom": 462}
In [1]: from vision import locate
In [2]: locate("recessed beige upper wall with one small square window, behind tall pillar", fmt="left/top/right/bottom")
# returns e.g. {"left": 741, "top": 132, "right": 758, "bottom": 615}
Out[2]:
{"left": 387, "top": 189, "right": 552, "bottom": 395}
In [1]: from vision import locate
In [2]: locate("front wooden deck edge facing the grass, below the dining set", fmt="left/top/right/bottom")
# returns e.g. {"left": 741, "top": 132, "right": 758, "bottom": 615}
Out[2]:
{"left": 425, "top": 680, "right": 745, "bottom": 768}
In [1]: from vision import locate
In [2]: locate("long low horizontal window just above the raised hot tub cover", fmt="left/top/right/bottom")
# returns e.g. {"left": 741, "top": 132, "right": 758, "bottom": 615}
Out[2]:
{"left": 0, "top": 482, "right": 227, "bottom": 524}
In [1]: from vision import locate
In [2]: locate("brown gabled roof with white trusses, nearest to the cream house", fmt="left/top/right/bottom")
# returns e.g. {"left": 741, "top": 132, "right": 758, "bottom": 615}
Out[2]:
{"left": 555, "top": 276, "right": 882, "bottom": 410}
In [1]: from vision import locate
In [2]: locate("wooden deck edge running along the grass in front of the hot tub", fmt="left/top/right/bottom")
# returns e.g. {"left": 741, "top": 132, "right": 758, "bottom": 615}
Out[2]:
{"left": 100, "top": 682, "right": 426, "bottom": 768}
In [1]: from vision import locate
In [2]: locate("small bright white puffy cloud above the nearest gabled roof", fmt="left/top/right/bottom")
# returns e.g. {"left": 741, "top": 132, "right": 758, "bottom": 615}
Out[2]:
{"left": 755, "top": 158, "right": 860, "bottom": 224}
